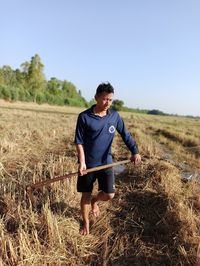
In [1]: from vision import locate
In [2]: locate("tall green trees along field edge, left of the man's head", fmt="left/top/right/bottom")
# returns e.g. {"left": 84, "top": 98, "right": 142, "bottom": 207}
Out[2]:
{"left": 0, "top": 54, "right": 88, "bottom": 106}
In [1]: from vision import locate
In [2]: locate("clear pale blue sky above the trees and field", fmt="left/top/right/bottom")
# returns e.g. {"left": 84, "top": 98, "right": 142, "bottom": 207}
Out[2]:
{"left": 0, "top": 0, "right": 200, "bottom": 116}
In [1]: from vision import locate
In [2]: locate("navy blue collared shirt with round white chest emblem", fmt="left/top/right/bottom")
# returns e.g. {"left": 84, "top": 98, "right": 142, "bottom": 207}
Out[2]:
{"left": 74, "top": 106, "right": 138, "bottom": 167}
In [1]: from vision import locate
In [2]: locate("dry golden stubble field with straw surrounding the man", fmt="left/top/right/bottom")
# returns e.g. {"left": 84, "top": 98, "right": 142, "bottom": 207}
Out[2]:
{"left": 0, "top": 101, "right": 200, "bottom": 266}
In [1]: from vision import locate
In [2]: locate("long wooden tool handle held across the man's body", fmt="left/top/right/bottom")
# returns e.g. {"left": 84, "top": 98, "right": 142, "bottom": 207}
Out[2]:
{"left": 28, "top": 160, "right": 131, "bottom": 190}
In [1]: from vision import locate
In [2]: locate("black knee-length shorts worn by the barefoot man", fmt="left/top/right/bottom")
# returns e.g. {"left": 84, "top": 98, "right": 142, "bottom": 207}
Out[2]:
{"left": 77, "top": 168, "right": 115, "bottom": 193}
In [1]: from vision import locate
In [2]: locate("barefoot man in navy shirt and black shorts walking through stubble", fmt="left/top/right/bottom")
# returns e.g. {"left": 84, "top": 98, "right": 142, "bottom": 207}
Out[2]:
{"left": 74, "top": 83, "right": 141, "bottom": 235}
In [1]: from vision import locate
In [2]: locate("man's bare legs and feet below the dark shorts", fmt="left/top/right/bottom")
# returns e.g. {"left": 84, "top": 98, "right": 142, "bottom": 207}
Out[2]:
{"left": 80, "top": 191, "right": 115, "bottom": 235}
